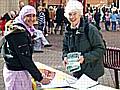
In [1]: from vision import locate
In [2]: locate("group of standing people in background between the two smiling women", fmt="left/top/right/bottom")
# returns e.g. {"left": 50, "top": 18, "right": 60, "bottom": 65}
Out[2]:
{"left": 37, "top": 5, "right": 65, "bottom": 36}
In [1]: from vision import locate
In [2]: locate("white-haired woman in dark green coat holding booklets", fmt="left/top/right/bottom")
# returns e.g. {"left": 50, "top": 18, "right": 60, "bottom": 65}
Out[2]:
{"left": 63, "top": 0, "right": 105, "bottom": 81}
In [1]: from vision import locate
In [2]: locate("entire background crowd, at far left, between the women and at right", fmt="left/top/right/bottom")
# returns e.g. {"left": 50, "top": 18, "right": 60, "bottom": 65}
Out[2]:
{"left": 0, "top": 2, "right": 120, "bottom": 51}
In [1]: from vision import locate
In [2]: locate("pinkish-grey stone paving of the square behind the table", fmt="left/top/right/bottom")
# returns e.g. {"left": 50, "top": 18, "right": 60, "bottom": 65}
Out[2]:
{"left": 0, "top": 31, "right": 120, "bottom": 90}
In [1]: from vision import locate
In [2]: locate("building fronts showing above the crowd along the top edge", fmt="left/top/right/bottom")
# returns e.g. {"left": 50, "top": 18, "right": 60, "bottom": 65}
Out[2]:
{"left": 0, "top": 0, "right": 120, "bottom": 15}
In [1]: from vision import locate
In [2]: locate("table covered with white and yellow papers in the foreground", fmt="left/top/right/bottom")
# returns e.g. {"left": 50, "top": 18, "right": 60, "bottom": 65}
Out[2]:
{"left": 35, "top": 62, "right": 118, "bottom": 90}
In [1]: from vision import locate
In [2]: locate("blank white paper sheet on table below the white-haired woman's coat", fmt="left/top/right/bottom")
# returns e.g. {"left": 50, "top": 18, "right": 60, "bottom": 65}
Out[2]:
{"left": 71, "top": 74, "right": 98, "bottom": 90}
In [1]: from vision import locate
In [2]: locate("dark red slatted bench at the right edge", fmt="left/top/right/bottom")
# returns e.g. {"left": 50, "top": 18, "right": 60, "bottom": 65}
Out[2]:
{"left": 103, "top": 47, "right": 120, "bottom": 89}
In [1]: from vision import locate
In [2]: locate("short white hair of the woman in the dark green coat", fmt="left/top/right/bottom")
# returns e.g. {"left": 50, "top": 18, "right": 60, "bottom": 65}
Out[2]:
{"left": 64, "top": 0, "right": 83, "bottom": 18}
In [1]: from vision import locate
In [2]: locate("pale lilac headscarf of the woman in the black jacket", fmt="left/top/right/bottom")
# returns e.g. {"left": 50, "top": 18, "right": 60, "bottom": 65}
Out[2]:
{"left": 0, "top": 5, "right": 36, "bottom": 47}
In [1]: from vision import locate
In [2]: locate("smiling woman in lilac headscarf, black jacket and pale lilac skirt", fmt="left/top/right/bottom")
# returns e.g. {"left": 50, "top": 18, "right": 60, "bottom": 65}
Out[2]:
{"left": 3, "top": 5, "right": 50, "bottom": 90}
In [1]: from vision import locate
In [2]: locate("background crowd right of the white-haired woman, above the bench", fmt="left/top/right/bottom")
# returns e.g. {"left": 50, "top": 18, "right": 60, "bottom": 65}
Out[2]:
{"left": 85, "top": 6, "right": 120, "bottom": 32}
